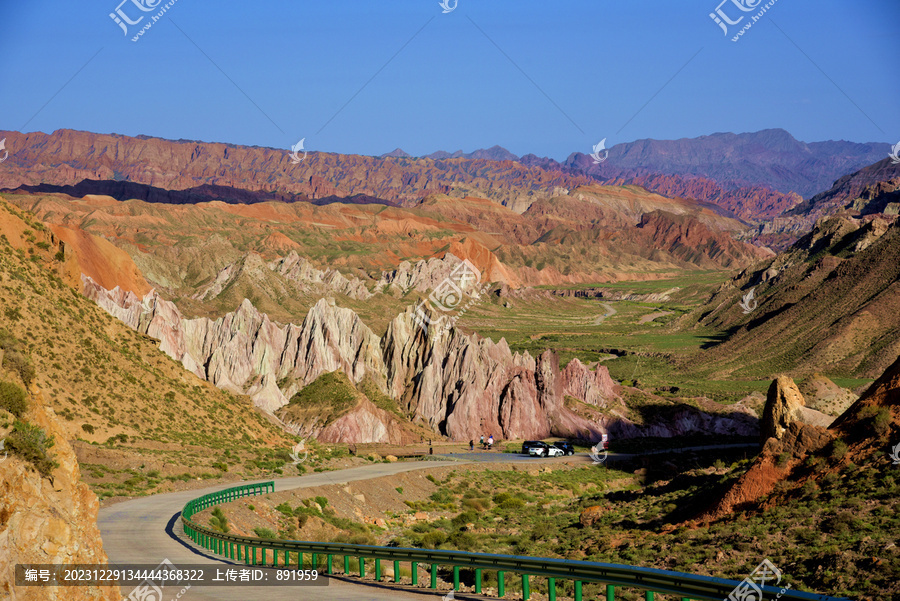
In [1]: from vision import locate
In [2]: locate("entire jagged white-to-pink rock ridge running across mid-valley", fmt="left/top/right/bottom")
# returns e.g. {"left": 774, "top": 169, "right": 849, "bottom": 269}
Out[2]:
{"left": 84, "top": 277, "right": 753, "bottom": 442}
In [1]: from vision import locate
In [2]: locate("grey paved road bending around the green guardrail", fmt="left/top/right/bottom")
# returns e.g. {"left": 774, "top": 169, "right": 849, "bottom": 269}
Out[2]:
{"left": 98, "top": 461, "right": 460, "bottom": 601}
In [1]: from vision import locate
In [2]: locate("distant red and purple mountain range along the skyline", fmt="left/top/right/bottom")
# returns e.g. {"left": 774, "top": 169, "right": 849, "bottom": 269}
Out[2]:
{"left": 0, "top": 130, "right": 889, "bottom": 223}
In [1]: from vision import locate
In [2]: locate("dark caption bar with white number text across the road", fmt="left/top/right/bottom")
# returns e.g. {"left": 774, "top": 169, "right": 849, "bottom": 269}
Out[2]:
{"left": 16, "top": 559, "right": 328, "bottom": 591}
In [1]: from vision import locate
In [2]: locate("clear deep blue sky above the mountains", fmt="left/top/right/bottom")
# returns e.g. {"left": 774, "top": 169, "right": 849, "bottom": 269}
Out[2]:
{"left": 0, "top": 0, "right": 900, "bottom": 159}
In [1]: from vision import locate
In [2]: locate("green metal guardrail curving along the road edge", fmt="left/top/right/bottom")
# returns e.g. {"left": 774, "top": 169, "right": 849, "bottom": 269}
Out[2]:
{"left": 181, "top": 482, "right": 847, "bottom": 601}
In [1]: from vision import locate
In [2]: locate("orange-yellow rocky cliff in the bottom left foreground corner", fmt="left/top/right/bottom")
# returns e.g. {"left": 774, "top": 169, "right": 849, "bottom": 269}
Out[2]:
{"left": 0, "top": 387, "right": 122, "bottom": 601}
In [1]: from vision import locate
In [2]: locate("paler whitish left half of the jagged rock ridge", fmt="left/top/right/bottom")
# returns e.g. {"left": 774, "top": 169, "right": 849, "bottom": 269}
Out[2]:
{"left": 84, "top": 276, "right": 384, "bottom": 411}
